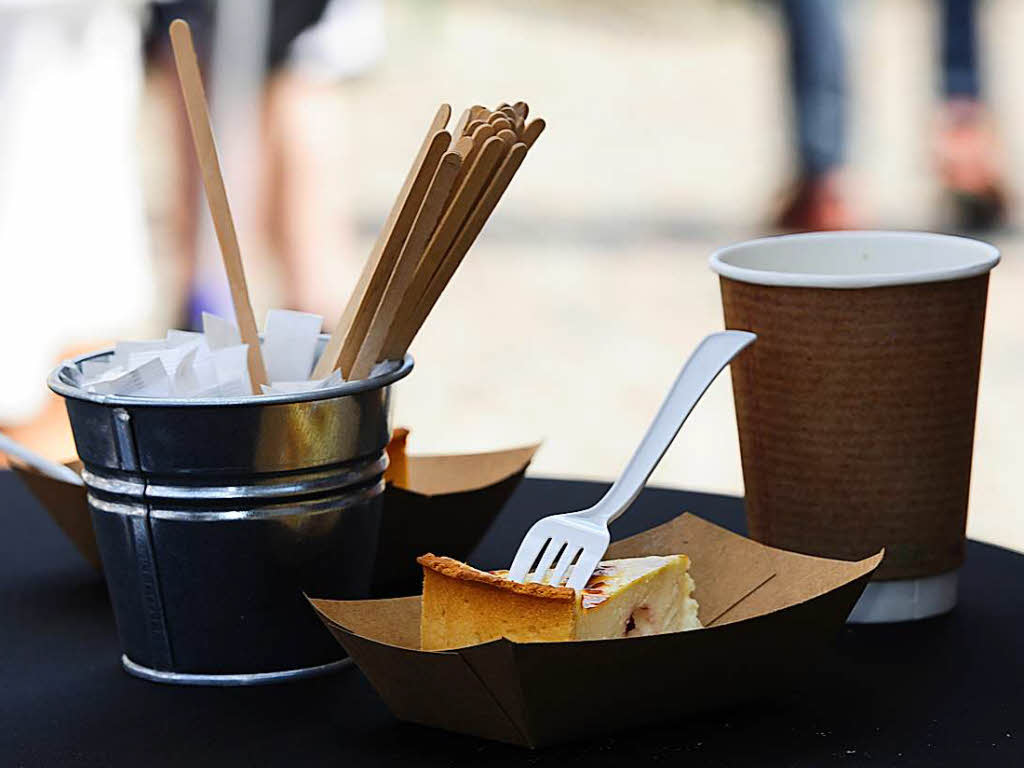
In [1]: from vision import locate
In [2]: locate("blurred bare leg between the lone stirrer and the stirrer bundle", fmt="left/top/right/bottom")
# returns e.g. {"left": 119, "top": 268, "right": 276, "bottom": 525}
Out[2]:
{"left": 265, "top": 0, "right": 383, "bottom": 327}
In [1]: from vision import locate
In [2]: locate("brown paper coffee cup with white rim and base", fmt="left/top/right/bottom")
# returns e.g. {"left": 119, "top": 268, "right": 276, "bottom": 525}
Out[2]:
{"left": 711, "top": 231, "right": 999, "bottom": 622}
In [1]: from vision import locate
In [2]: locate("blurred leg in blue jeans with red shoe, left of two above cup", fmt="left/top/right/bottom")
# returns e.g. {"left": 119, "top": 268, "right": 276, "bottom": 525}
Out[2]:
{"left": 776, "top": 0, "right": 850, "bottom": 229}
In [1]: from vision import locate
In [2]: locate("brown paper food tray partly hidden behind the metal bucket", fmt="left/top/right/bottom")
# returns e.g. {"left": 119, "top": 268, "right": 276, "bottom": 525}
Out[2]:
{"left": 11, "top": 443, "right": 540, "bottom": 596}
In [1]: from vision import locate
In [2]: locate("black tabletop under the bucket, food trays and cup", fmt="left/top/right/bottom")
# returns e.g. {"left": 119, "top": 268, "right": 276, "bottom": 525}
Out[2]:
{"left": 0, "top": 472, "right": 1024, "bottom": 768}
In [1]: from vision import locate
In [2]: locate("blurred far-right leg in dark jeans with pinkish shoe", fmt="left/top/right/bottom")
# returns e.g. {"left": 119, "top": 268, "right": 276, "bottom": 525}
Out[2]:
{"left": 937, "top": 0, "right": 1006, "bottom": 229}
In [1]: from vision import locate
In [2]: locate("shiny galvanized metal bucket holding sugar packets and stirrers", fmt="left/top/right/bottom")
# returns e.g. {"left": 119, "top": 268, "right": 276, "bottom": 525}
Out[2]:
{"left": 48, "top": 342, "right": 413, "bottom": 685}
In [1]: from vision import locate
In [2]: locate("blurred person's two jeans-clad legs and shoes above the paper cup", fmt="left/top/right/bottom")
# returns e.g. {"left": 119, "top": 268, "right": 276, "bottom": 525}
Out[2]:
{"left": 776, "top": 0, "right": 1006, "bottom": 230}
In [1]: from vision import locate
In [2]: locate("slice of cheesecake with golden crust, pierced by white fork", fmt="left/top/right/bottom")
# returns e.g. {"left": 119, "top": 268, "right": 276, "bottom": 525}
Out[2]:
{"left": 417, "top": 554, "right": 700, "bottom": 650}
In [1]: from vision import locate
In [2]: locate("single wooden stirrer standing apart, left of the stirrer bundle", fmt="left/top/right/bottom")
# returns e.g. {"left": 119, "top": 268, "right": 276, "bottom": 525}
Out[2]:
{"left": 169, "top": 18, "right": 268, "bottom": 394}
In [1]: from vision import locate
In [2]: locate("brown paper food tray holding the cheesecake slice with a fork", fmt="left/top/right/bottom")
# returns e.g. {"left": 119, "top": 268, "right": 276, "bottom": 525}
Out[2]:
{"left": 310, "top": 514, "right": 883, "bottom": 746}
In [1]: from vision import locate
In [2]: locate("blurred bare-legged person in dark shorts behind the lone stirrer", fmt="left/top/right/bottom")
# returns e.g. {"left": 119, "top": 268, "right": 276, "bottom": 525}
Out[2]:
{"left": 151, "top": 0, "right": 384, "bottom": 327}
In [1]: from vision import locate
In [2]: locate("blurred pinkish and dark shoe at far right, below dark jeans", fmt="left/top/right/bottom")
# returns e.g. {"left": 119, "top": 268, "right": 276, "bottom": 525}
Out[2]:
{"left": 935, "top": 99, "right": 1007, "bottom": 231}
